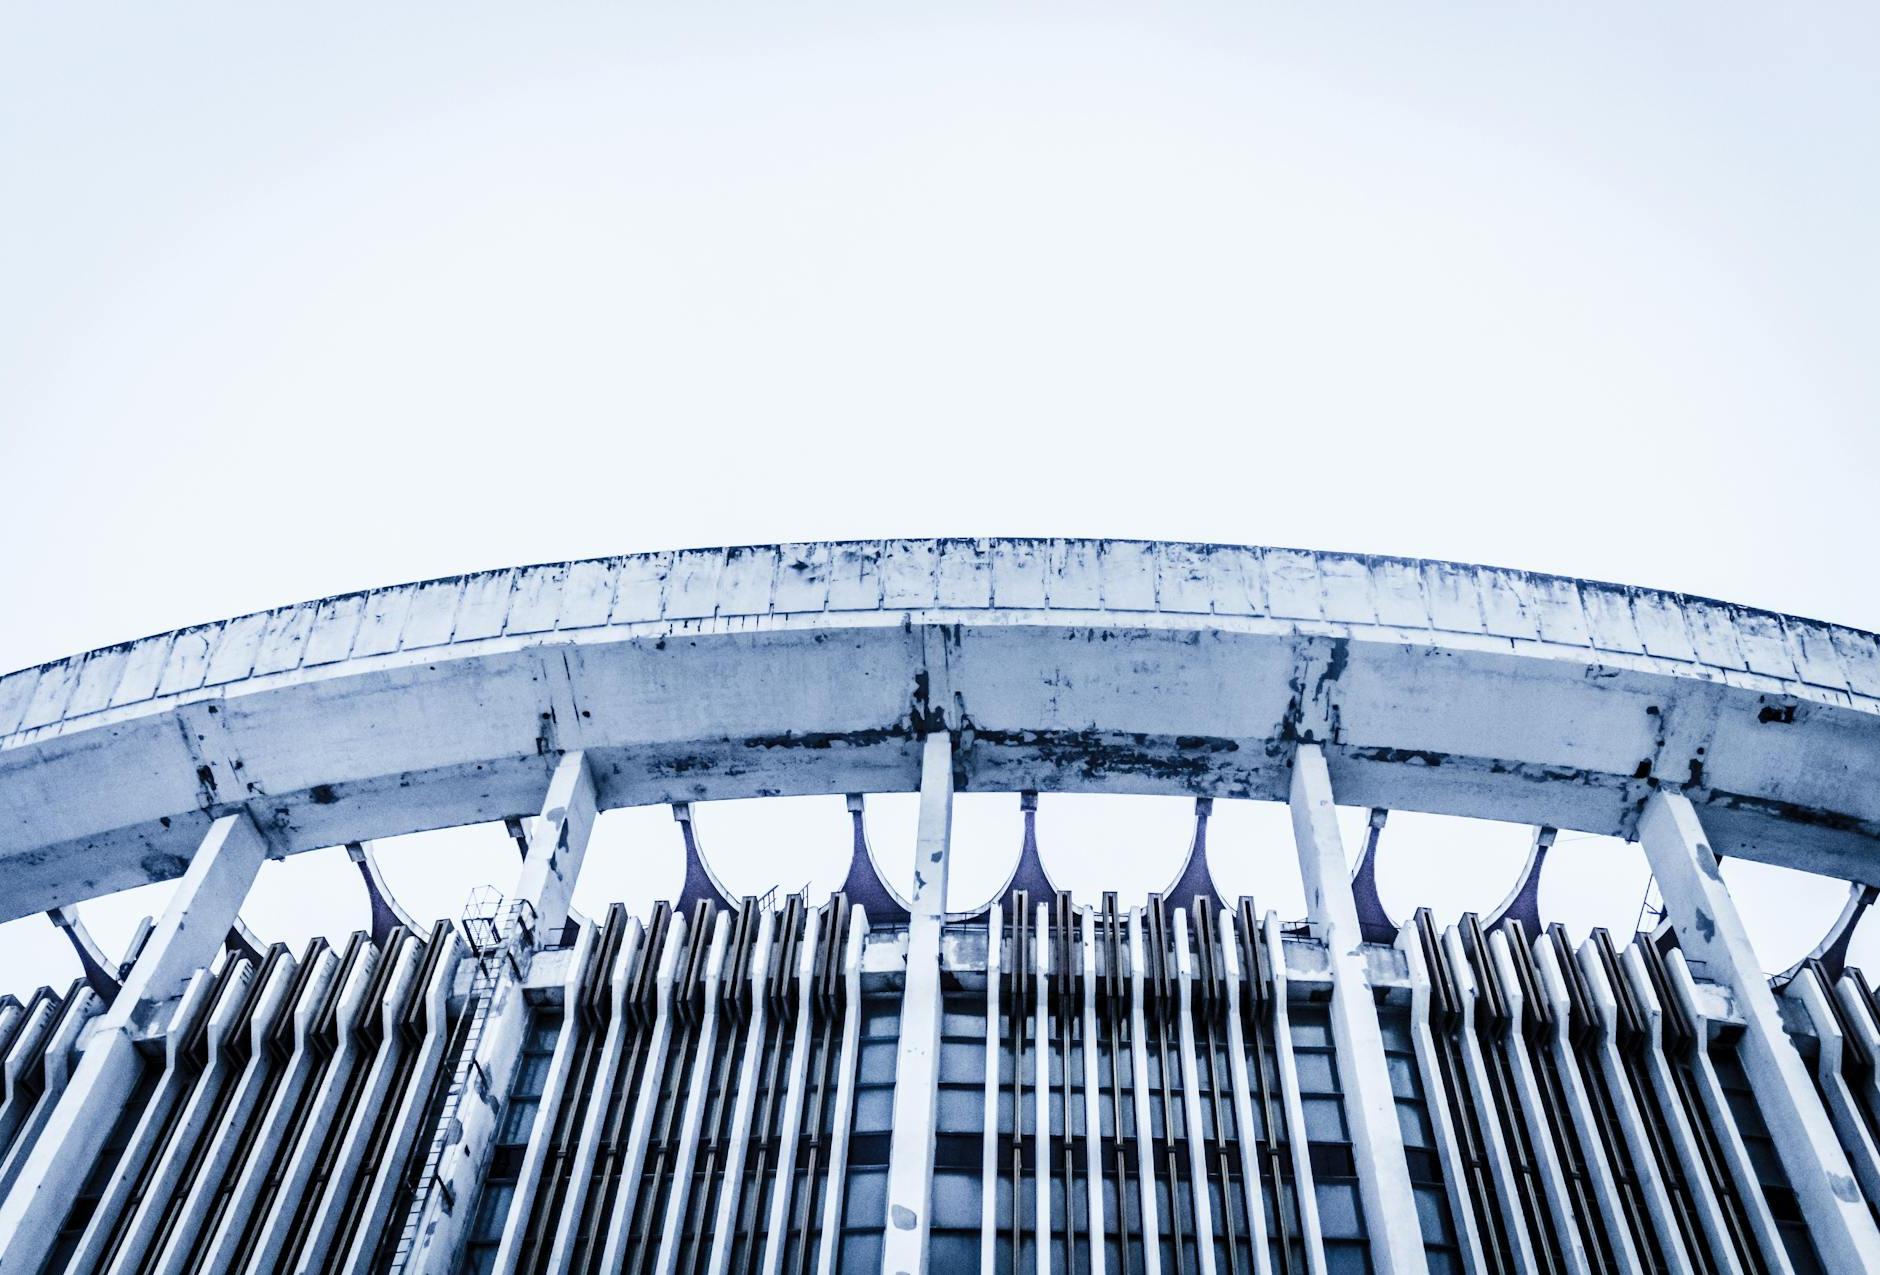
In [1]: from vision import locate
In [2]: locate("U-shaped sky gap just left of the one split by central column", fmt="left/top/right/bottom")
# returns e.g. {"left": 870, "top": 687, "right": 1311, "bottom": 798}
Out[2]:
{"left": 688, "top": 795, "right": 854, "bottom": 905}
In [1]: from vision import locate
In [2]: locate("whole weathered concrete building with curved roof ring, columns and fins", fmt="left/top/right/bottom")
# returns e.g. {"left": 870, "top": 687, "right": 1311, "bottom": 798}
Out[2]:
{"left": 0, "top": 540, "right": 1880, "bottom": 1275}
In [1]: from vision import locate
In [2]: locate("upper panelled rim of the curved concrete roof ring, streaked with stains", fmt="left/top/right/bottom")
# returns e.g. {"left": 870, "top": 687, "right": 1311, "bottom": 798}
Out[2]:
{"left": 0, "top": 538, "right": 1880, "bottom": 743}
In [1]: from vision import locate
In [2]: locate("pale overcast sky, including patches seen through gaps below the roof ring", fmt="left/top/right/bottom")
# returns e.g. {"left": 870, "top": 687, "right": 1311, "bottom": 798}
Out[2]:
{"left": 0, "top": 4, "right": 1880, "bottom": 989}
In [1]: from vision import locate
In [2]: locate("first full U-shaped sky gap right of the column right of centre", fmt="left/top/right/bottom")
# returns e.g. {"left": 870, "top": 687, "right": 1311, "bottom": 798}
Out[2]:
{"left": 1376, "top": 811, "right": 1551, "bottom": 925}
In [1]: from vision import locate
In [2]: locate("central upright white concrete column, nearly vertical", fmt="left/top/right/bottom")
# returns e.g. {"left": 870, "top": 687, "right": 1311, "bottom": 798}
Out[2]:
{"left": 879, "top": 732, "right": 953, "bottom": 1275}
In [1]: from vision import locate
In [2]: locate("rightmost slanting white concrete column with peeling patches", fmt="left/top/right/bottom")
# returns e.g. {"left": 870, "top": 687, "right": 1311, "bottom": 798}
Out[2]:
{"left": 1639, "top": 792, "right": 1880, "bottom": 1271}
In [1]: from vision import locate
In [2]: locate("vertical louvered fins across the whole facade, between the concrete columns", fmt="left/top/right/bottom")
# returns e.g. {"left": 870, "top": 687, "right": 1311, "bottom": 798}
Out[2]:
{"left": 0, "top": 891, "right": 1880, "bottom": 1275}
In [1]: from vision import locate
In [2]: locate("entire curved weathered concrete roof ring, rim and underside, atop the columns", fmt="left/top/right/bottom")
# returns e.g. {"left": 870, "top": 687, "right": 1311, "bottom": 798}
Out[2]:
{"left": 0, "top": 540, "right": 1880, "bottom": 920}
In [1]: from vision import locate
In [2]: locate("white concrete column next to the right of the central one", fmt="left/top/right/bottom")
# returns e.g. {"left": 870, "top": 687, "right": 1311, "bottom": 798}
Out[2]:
{"left": 1292, "top": 745, "right": 1429, "bottom": 1275}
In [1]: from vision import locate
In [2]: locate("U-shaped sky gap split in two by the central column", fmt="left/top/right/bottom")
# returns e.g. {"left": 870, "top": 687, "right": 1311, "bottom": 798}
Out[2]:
{"left": 863, "top": 792, "right": 1025, "bottom": 914}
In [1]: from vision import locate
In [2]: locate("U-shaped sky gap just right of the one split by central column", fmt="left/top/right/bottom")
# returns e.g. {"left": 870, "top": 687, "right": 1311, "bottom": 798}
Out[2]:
{"left": 1038, "top": 792, "right": 1196, "bottom": 908}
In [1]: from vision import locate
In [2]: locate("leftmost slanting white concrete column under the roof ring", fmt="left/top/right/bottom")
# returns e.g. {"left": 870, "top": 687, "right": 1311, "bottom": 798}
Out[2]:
{"left": 0, "top": 812, "right": 267, "bottom": 1275}
